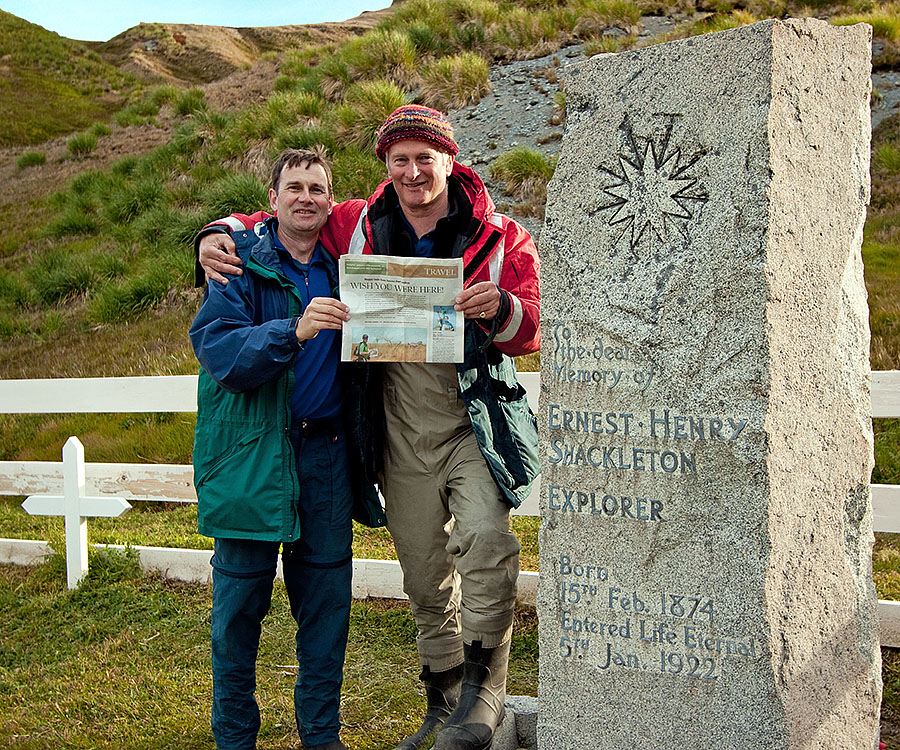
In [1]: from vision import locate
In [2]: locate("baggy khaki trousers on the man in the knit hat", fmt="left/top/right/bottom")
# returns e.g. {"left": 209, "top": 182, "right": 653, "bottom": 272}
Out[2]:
{"left": 382, "top": 362, "right": 520, "bottom": 672}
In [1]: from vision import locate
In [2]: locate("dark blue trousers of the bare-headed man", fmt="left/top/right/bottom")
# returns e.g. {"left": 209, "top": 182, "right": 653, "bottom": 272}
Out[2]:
{"left": 211, "top": 433, "right": 353, "bottom": 750}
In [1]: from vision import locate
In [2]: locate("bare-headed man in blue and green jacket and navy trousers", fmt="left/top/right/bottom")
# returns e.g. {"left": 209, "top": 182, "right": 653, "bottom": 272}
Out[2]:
{"left": 190, "top": 150, "right": 383, "bottom": 750}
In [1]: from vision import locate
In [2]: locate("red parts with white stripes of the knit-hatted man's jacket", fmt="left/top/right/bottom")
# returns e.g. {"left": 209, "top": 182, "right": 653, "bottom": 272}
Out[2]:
{"left": 206, "top": 162, "right": 541, "bottom": 357}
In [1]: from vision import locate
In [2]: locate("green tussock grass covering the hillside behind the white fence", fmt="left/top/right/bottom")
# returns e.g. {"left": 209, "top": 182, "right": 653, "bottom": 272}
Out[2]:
{"left": 0, "top": 0, "right": 900, "bottom": 464}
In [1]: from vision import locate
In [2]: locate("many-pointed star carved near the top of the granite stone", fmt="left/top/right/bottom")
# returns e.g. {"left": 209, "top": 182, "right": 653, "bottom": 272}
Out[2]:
{"left": 600, "top": 121, "right": 709, "bottom": 254}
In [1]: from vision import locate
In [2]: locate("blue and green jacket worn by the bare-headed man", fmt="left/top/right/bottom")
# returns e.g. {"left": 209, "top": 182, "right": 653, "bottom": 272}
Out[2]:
{"left": 190, "top": 220, "right": 385, "bottom": 542}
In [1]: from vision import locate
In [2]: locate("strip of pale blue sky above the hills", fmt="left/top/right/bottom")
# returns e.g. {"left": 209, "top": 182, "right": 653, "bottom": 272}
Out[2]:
{"left": 0, "top": 0, "right": 391, "bottom": 42}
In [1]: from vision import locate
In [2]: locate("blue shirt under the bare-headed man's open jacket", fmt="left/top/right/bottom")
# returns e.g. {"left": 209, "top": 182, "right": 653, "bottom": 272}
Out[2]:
{"left": 272, "top": 233, "right": 342, "bottom": 423}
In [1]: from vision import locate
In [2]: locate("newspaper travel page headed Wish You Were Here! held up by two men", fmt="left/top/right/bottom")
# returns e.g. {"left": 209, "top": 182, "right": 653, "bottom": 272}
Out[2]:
{"left": 339, "top": 255, "right": 465, "bottom": 362}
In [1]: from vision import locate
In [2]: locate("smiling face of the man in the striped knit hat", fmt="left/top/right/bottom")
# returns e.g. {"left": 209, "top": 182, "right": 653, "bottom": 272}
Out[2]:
{"left": 386, "top": 141, "right": 453, "bottom": 211}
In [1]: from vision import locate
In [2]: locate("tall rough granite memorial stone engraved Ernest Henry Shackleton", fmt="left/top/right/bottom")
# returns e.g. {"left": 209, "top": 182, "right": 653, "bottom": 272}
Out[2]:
{"left": 538, "top": 19, "right": 881, "bottom": 750}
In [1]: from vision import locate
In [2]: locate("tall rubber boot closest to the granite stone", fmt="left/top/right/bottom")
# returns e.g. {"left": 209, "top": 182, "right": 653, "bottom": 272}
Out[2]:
{"left": 434, "top": 641, "right": 510, "bottom": 750}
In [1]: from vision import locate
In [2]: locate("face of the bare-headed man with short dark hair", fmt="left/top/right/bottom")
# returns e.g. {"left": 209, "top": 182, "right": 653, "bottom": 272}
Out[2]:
{"left": 269, "top": 164, "right": 331, "bottom": 237}
